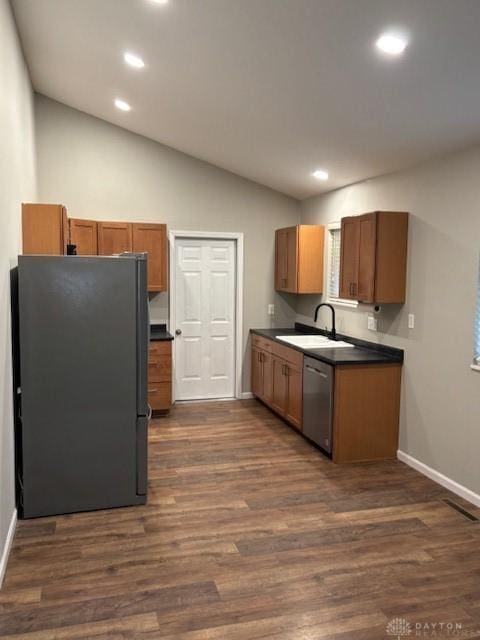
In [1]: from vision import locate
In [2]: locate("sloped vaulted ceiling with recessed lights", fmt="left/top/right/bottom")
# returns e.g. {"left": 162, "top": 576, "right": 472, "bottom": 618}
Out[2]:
{"left": 12, "top": 0, "right": 480, "bottom": 198}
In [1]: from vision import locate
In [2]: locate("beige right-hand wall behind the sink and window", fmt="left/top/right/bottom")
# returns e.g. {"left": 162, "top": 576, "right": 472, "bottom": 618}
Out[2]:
{"left": 298, "top": 148, "right": 480, "bottom": 493}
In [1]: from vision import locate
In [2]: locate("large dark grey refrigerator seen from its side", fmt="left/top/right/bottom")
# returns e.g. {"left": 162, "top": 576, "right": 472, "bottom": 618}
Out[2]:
{"left": 12, "top": 254, "right": 149, "bottom": 518}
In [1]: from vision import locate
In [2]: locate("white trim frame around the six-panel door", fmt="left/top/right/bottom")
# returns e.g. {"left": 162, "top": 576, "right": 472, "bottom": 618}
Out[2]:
{"left": 168, "top": 231, "right": 243, "bottom": 401}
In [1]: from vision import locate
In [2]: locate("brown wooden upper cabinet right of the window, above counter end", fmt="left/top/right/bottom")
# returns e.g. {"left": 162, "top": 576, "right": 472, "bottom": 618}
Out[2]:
{"left": 340, "top": 211, "right": 408, "bottom": 304}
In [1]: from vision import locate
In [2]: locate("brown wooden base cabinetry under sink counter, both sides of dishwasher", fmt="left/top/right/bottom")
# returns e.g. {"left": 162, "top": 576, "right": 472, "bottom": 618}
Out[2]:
{"left": 252, "top": 335, "right": 402, "bottom": 463}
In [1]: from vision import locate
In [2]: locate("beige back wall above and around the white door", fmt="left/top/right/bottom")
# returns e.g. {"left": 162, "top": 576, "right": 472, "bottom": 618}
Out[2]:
{"left": 36, "top": 96, "right": 300, "bottom": 390}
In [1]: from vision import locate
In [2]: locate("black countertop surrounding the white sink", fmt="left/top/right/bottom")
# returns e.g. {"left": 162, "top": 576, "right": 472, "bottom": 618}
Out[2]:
{"left": 250, "top": 323, "right": 403, "bottom": 365}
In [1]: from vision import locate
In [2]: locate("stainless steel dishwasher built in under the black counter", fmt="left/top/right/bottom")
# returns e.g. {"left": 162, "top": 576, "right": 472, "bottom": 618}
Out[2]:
{"left": 303, "top": 356, "right": 333, "bottom": 456}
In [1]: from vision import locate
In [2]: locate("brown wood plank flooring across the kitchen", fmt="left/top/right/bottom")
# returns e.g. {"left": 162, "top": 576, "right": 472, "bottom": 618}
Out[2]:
{"left": 0, "top": 400, "right": 480, "bottom": 640}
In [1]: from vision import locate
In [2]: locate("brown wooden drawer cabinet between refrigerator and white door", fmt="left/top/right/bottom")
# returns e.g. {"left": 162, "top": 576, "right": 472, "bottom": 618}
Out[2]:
{"left": 148, "top": 341, "right": 172, "bottom": 411}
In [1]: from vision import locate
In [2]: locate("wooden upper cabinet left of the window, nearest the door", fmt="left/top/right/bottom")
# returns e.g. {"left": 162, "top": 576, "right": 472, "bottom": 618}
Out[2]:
{"left": 275, "top": 224, "right": 325, "bottom": 293}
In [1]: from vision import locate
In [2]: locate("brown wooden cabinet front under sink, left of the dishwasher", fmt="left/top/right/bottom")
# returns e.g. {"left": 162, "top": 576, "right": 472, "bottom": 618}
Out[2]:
{"left": 252, "top": 336, "right": 303, "bottom": 429}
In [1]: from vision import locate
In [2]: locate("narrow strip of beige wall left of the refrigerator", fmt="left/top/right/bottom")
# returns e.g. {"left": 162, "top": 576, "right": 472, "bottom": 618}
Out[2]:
{"left": 0, "top": 0, "right": 36, "bottom": 582}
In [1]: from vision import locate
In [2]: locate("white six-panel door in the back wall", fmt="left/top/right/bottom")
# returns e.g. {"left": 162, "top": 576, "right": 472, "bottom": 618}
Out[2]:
{"left": 173, "top": 238, "right": 235, "bottom": 400}
